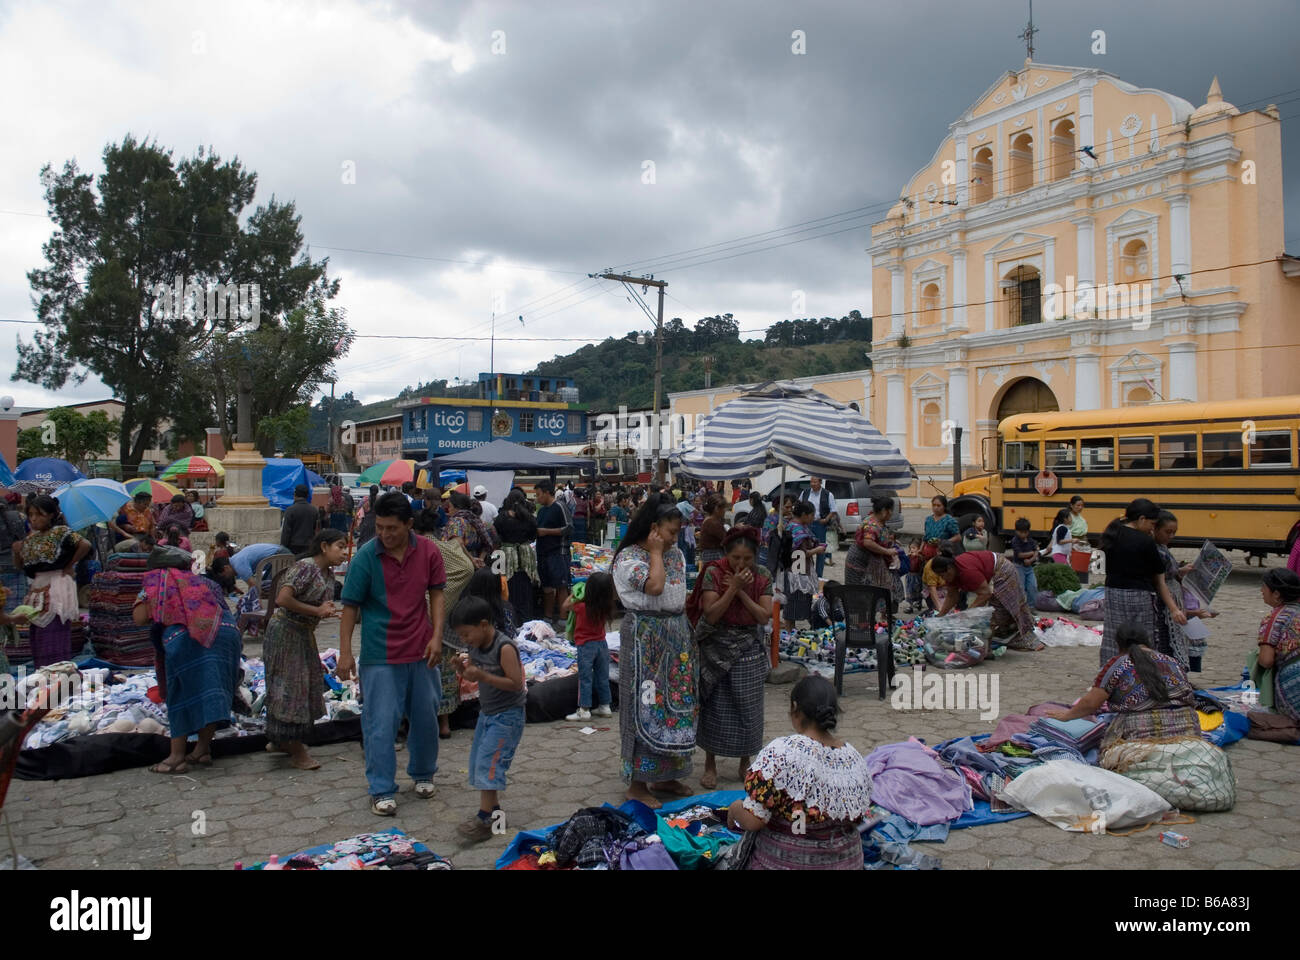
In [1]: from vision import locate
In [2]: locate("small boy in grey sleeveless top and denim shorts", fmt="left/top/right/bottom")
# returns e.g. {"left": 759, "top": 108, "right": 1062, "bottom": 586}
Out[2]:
{"left": 451, "top": 596, "right": 528, "bottom": 843}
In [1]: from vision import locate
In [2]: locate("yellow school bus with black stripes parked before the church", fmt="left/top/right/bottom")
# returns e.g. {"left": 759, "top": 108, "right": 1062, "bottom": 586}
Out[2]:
{"left": 949, "top": 397, "right": 1300, "bottom": 555}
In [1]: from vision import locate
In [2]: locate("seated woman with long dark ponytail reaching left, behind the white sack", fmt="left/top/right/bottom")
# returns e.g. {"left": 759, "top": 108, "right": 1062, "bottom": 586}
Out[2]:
{"left": 1048, "top": 624, "right": 1201, "bottom": 766}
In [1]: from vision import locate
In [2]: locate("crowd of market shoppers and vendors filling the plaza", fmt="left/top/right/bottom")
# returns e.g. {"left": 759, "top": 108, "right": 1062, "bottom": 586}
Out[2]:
{"left": 12, "top": 463, "right": 1300, "bottom": 869}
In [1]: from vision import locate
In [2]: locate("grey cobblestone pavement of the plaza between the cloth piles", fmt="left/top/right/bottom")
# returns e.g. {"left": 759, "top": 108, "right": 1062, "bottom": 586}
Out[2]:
{"left": 5, "top": 554, "right": 1300, "bottom": 870}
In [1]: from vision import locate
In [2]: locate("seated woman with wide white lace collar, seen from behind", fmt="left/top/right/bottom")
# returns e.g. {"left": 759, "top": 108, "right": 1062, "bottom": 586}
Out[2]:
{"left": 727, "top": 676, "right": 871, "bottom": 870}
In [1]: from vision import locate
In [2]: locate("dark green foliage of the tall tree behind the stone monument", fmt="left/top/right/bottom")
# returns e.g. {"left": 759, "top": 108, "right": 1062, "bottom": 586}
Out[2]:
{"left": 13, "top": 135, "right": 350, "bottom": 464}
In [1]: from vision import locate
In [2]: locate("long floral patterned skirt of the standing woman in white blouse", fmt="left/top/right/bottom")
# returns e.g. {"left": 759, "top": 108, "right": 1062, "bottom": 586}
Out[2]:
{"left": 619, "top": 611, "right": 699, "bottom": 783}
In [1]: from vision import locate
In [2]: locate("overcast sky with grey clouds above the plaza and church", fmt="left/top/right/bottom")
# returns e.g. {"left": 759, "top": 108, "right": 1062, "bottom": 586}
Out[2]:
{"left": 0, "top": 0, "right": 1300, "bottom": 406}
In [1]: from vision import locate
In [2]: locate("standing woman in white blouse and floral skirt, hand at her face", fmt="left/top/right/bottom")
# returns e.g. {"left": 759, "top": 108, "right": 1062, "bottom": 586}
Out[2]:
{"left": 614, "top": 493, "right": 699, "bottom": 809}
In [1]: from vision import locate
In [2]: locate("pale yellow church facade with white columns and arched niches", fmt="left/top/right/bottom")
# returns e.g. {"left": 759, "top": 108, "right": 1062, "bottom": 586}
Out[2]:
{"left": 870, "top": 61, "right": 1300, "bottom": 475}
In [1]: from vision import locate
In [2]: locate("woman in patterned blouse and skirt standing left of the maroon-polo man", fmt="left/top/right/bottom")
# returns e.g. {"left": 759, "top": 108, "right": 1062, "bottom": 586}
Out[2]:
{"left": 261, "top": 528, "right": 347, "bottom": 770}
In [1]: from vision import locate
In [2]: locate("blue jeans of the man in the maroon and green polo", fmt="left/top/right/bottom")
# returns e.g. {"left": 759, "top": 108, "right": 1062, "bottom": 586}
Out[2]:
{"left": 359, "top": 660, "right": 442, "bottom": 797}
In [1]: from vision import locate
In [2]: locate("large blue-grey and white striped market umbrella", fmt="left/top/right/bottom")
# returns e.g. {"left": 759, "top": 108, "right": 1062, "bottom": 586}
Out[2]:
{"left": 670, "top": 380, "right": 913, "bottom": 490}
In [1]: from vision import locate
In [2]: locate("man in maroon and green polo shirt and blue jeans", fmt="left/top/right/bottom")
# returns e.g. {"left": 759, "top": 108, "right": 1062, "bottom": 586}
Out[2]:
{"left": 335, "top": 493, "right": 447, "bottom": 817}
